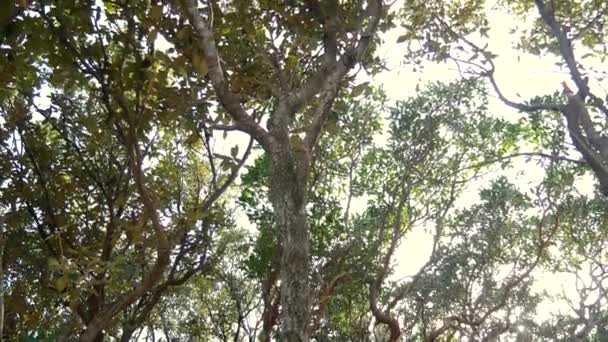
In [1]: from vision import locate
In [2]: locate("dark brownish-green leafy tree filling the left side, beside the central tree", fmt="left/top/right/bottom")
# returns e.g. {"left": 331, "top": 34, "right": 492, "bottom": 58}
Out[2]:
{"left": 0, "top": 2, "right": 251, "bottom": 341}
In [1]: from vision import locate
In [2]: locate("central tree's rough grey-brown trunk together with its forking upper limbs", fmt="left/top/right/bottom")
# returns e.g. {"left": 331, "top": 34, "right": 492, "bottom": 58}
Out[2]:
{"left": 181, "top": 0, "right": 384, "bottom": 342}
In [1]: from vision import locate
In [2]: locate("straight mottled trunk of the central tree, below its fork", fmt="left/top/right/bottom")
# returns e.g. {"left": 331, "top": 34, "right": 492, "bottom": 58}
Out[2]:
{"left": 270, "top": 145, "right": 310, "bottom": 342}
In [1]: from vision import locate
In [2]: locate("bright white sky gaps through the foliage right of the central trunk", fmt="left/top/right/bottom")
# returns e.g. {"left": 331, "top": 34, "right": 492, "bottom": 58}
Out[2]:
{"left": 374, "top": 2, "right": 608, "bottom": 328}
